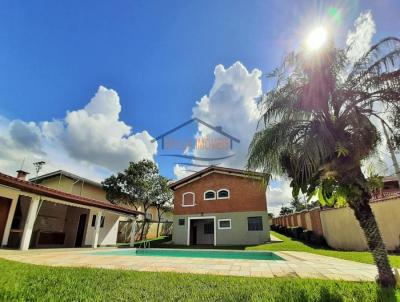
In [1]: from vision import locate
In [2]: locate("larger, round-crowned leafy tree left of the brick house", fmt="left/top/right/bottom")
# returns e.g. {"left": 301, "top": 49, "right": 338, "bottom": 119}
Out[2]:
{"left": 102, "top": 160, "right": 160, "bottom": 240}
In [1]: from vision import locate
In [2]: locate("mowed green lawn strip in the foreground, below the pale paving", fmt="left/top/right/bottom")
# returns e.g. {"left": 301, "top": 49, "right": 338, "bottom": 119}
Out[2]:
{"left": 0, "top": 259, "right": 400, "bottom": 302}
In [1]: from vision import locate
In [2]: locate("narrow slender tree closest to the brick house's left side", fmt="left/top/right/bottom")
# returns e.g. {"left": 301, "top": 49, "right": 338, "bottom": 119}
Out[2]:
{"left": 152, "top": 175, "right": 173, "bottom": 237}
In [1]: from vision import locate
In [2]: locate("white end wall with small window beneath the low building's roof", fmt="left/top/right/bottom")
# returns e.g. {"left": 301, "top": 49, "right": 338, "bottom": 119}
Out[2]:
{"left": 85, "top": 210, "right": 120, "bottom": 245}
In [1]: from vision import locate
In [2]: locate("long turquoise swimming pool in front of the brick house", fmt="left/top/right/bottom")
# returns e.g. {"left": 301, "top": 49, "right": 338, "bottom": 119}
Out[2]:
{"left": 92, "top": 249, "right": 284, "bottom": 260}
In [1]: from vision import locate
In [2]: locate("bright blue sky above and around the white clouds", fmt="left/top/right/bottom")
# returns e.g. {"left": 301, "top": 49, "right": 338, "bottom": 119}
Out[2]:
{"left": 0, "top": 0, "right": 400, "bottom": 212}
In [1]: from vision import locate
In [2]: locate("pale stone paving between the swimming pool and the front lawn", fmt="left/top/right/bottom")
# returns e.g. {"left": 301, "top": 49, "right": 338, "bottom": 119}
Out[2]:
{"left": 0, "top": 248, "right": 377, "bottom": 281}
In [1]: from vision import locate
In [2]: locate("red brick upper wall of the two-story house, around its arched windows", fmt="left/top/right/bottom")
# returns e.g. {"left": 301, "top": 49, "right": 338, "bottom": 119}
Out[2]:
{"left": 174, "top": 173, "right": 267, "bottom": 215}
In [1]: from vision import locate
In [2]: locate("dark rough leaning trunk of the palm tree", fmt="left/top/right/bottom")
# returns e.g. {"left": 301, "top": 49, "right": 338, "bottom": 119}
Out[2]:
{"left": 350, "top": 192, "right": 396, "bottom": 287}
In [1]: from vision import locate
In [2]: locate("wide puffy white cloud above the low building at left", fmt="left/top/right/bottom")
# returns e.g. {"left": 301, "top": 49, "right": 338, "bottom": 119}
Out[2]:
{"left": 0, "top": 86, "right": 157, "bottom": 180}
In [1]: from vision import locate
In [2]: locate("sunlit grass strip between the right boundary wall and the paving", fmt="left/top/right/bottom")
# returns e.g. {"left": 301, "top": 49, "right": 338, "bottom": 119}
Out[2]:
{"left": 246, "top": 231, "right": 400, "bottom": 268}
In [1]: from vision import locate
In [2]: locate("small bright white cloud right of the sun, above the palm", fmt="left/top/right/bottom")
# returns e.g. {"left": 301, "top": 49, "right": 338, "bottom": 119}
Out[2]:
{"left": 346, "top": 11, "right": 376, "bottom": 63}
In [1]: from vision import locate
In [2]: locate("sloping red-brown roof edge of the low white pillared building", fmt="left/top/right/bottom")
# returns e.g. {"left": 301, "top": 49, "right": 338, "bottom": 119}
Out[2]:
{"left": 0, "top": 173, "right": 143, "bottom": 215}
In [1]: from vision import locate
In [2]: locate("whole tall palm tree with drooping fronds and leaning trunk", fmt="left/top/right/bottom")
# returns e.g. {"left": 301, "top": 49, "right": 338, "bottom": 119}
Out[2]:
{"left": 247, "top": 38, "right": 400, "bottom": 287}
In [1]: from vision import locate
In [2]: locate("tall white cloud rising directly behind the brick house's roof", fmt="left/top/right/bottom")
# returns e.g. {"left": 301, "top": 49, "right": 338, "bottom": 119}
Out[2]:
{"left": 174, "top": 62, "right": 261, "bottom": 178}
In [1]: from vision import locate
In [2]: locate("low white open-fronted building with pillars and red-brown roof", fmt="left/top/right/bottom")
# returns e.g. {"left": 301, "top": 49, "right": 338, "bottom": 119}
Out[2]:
{"left": 0, "top": 171, "right": 143, "bottom": 250}
